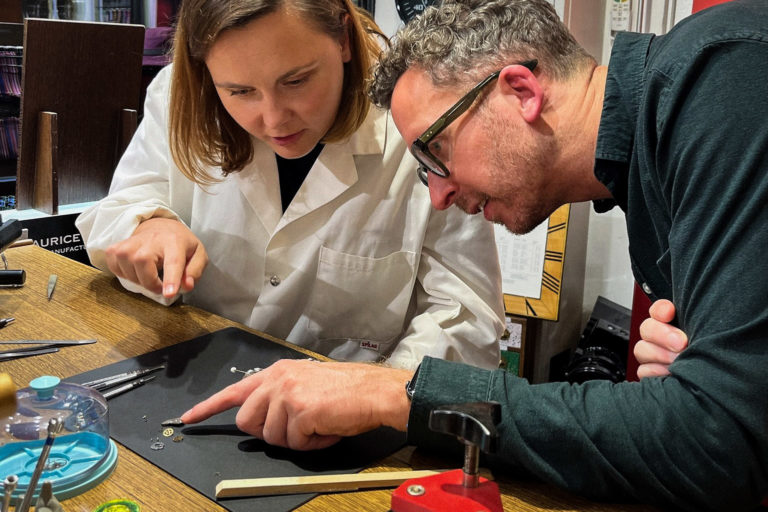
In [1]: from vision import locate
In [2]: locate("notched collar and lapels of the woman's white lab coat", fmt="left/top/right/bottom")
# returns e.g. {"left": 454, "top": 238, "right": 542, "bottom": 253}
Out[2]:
{"left": 235, "top": 108, "right": 388, "bottom": 235}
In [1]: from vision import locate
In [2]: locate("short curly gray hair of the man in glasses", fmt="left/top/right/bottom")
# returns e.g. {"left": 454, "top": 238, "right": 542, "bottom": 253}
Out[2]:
{"left": 368, "top": 0, "right": 595, "bottom": 108}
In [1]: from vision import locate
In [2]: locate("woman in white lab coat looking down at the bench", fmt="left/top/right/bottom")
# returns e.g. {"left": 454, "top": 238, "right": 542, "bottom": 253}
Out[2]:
{"left": 77, "top": 0, "right": 503, "bottom": 368}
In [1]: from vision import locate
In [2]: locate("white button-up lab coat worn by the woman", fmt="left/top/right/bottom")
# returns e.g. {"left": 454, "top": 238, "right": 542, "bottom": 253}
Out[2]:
{"left": 76, "top": 66, "right": 504, "bottom": 368}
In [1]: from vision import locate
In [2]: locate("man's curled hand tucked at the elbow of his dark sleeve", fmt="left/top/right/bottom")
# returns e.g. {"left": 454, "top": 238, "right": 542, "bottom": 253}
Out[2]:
{"left": 634, "top": 299, "right": 688, "bottom": 379}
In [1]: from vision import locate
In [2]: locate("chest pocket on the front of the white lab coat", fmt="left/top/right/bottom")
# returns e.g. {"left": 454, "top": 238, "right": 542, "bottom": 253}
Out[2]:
{"left": 308, "top": 247, "right": 416, "bottom": 348}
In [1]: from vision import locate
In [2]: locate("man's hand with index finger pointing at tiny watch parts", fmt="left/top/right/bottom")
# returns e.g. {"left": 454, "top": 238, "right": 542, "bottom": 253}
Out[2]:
{"left": 181, "top": 359, "right": 413, "bottom": 450}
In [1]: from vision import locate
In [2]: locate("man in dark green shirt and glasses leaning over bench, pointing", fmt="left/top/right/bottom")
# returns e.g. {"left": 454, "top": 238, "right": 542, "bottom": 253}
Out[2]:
{"left": 184, "top": 0, "right": 768, "bottom": 511}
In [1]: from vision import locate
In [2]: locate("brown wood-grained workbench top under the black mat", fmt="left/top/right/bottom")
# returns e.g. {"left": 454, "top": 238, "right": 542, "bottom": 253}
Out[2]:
{"left": 0, "top": 246, "right": 656, "bottom": 512}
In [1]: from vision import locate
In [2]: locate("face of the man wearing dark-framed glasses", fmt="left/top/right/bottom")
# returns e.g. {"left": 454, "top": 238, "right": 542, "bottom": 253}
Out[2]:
{"left": 392, "top": 69, "right": 558, "bottom": 233}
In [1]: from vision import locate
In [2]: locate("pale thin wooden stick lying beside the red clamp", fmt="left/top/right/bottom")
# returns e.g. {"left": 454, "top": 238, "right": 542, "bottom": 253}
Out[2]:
{"left": 216, "top": 470, "right": 446, "bottom": 498}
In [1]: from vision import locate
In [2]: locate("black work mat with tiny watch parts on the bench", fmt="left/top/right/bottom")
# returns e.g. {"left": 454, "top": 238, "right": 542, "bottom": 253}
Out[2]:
{"left": 66, "top": 328, "right": 405, "bottom": 512}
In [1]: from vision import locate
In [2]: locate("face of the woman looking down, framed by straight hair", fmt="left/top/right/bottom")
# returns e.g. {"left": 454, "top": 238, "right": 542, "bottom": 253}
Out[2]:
{"left": 205, "top": 10, "right": 351, "bottom": 158}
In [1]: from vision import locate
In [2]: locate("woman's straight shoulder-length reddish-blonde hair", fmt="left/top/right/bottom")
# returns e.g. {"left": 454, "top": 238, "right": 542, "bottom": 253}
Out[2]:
{"left": 169, "top": 0, "right": 386, "bottom": 184}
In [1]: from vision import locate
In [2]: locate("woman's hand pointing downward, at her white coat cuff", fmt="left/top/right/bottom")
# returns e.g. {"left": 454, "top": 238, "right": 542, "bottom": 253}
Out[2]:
{"left": 106, "top": 218, "right": 208, "bottom": 298}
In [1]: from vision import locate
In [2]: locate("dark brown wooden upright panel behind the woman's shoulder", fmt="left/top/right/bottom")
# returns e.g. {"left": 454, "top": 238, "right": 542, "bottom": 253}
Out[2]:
{"left": 16, "top": 18, "right": 144, "bottom": 209}
